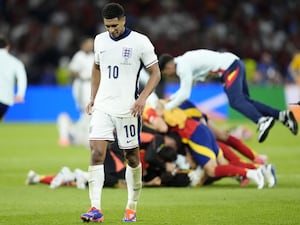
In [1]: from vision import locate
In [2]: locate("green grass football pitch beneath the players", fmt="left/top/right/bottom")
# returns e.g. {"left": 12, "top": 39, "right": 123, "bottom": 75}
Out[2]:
{"left": 0, "top": 121, "right": 300, "bottom": 225}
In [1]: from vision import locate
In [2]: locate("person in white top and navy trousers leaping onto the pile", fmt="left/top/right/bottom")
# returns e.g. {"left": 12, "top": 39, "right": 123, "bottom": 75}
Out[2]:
{"left": 159, "top": 49, "right": 298, "bottom": 142}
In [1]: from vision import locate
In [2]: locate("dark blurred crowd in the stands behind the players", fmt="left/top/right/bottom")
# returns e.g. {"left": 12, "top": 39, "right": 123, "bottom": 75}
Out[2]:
{"left": 0, "top": 0, "right": 300, "bottom": 85}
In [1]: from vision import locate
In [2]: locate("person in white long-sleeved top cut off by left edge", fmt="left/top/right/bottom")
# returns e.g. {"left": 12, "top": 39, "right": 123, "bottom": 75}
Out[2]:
{"left": 0, "top": 36, "right": 27, "bottom": 121}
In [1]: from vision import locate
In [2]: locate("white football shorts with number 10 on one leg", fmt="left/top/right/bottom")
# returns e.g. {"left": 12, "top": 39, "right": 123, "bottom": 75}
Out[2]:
{"left": 89, "top": 110, "right": 141, "bottom": 149}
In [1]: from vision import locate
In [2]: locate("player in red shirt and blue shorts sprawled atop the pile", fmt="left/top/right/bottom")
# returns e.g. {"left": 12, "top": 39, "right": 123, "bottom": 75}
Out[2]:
{"left": 144, "top": 101, "right": 276, "bottom": 189}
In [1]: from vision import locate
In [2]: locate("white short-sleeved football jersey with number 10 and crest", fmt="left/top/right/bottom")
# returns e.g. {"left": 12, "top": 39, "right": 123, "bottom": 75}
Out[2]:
{"left": 94, "top": 29, "right": 158, "bottom": 117}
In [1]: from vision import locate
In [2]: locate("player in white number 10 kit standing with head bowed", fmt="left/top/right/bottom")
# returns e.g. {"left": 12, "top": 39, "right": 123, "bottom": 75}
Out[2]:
{"left": 81, "top": 3, "right": 160, "bottom": 222}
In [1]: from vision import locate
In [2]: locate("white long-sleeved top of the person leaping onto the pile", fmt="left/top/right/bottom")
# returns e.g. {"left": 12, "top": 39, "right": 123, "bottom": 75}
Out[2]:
{"left": 165, "top": 49, "right": 239, "bottom": 109}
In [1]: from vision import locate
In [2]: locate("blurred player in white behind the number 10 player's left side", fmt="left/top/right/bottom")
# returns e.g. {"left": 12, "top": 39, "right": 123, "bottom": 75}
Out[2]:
{"left": 57, "top": 38, "right": 94, "bottom": 146}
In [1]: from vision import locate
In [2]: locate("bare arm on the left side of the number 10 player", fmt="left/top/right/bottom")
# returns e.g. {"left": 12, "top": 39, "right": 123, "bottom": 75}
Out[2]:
{"left": 86, "top": 63, "right": 101, "bottom": 115}
